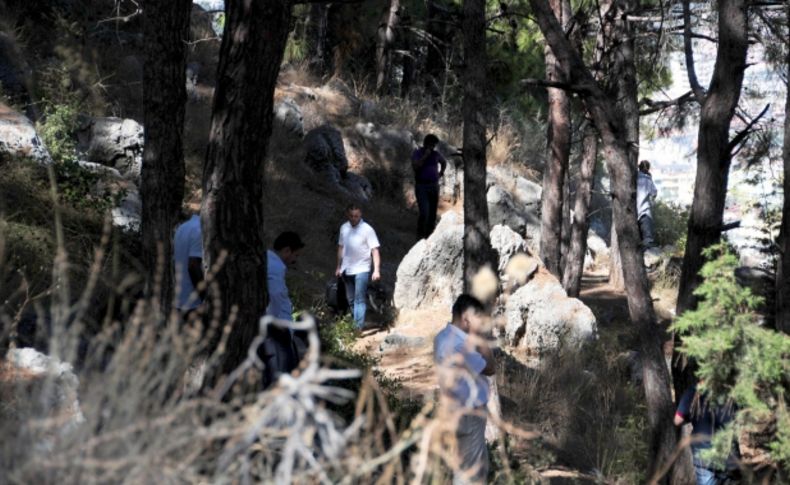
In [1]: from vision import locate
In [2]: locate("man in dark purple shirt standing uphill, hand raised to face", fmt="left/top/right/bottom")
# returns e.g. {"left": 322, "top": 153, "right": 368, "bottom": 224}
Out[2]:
{"left": 411, "top": 134, "right": 447, "bottom": 239}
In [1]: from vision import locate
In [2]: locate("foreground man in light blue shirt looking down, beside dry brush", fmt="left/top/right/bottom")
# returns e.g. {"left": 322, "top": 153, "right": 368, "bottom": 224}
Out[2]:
{"left": 433, "top": 294, "right": 496, "bottom": 484}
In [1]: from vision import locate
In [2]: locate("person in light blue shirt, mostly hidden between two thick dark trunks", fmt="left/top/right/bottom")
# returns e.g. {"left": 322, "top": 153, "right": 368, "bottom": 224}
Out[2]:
{"left": 173, "top": 213, "right": 203, "bottom": 314}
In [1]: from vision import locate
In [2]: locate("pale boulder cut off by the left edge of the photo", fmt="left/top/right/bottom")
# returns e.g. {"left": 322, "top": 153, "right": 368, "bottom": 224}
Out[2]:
{"left": 0, "top": 103, "right": 52, "bottom": 164}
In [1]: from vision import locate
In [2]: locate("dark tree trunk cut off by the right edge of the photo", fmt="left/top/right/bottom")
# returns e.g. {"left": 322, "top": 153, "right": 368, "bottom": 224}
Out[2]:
{"left": 776, "top": 3, "right": 790, "bottom": 334}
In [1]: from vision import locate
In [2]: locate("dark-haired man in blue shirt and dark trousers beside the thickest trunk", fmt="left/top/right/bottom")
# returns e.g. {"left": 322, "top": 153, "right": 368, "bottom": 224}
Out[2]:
{"left": 258, "top": 231, "right": 304, "bottom": 387}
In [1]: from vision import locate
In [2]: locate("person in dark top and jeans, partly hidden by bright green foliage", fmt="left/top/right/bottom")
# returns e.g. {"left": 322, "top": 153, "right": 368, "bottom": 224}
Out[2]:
{"left": 675, "top": 385, "right": 738, "bottom": 485}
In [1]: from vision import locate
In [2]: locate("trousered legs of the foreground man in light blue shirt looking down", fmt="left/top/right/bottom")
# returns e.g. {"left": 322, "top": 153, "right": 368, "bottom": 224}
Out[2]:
{"left": 453, "top": 414, "right": 488, "bottom": 485}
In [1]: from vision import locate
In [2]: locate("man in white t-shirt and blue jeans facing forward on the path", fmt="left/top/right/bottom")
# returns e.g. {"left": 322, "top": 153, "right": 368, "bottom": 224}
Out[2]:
{"left": 335, "top": 204, "right": 381, "bottom": 330}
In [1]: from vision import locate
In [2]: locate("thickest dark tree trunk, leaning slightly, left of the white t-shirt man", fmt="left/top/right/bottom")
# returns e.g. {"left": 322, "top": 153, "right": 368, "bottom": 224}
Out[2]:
{"left": 201, "top": 0, "right": 291, "bottom": 372}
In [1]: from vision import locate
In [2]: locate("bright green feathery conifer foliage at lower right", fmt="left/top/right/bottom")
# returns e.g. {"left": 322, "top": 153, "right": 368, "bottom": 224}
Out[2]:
{"left": 671, "top": 244, "right": 790, "bottom": 467}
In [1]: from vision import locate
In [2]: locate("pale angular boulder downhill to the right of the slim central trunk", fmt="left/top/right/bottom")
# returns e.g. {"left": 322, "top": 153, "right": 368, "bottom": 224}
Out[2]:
{"left": 505, "top": 269, "right": 597, "bottom": 356}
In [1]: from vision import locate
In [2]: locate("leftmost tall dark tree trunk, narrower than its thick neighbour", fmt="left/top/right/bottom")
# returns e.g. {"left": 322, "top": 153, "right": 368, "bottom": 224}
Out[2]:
{"left": 140, "top": 0, "right": 192, "bottom": 315}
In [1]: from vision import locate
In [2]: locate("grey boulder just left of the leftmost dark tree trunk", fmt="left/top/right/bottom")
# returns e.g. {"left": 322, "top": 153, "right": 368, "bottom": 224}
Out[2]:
{"left": 77, "top": 117, "right": 144, "bottom": 180}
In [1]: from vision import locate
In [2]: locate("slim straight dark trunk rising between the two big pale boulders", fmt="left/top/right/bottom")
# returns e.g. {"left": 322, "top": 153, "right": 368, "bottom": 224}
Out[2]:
{"left": 462, "top": 0, "right": 496, "bottom": 292}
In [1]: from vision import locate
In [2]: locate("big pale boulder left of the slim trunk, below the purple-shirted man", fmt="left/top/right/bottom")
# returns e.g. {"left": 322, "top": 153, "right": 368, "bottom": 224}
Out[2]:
{"left": 393, "top": 212, "right": 464, "bottom": 309}
